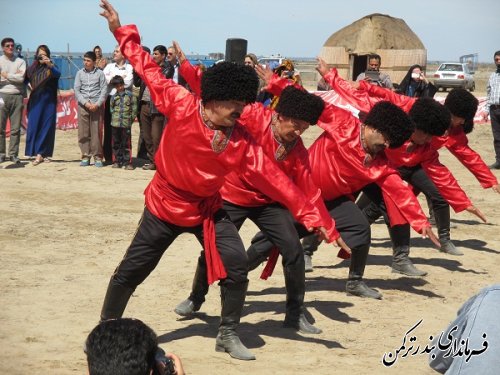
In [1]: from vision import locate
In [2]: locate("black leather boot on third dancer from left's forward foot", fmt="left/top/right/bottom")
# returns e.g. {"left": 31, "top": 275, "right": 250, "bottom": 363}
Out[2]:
{"left": 346, "top": 245, "right": 382, "bottom": 299}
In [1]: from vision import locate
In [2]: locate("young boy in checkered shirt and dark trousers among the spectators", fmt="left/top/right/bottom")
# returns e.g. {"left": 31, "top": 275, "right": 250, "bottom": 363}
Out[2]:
{"left": 109, "top": 75, "right": 137, "bottom": 170}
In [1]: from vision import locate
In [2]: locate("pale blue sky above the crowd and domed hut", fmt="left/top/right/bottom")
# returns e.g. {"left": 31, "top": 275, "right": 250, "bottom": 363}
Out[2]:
{"left": 0, "top": 0, "right": 500, "bottom": 62}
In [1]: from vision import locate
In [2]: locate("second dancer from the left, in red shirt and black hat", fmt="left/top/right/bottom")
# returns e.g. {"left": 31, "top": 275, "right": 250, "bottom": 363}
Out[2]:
{"left": 174, "top": 55, "right": 350, "bottom": 334}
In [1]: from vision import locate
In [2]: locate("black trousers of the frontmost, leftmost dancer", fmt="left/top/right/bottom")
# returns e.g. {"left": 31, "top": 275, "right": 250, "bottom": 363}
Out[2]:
{"left": 112, "top": 208, "right": 248, "bottom": 289}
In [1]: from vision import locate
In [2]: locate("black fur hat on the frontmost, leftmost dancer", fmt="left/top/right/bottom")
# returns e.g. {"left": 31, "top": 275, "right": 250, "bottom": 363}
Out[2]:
{"left": 201, "top": 61, "right": 259, "bottom": 103}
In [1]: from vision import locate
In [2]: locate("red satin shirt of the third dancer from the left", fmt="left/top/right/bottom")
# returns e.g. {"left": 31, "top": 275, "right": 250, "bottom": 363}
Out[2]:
{"left": 309, "top": 105, "right": 430, "bottom": 233}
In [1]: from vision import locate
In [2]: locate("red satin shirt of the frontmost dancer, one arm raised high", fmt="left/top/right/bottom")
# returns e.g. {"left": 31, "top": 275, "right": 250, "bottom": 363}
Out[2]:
{"left": 115, "top": 25, "right": 322, "bottom": 228}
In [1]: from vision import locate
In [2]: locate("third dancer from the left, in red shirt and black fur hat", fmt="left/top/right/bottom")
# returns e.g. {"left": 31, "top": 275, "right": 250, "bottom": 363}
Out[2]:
{"left": 247, "top": 92, "right": 437, "bottom": 299}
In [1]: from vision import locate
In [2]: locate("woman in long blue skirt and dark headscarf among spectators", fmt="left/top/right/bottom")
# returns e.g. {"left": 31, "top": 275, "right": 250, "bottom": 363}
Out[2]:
{"left": 25, "top": 44, "right": 61, "bottom": 166}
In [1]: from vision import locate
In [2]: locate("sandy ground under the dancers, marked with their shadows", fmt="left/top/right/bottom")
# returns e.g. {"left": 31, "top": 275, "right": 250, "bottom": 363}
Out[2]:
{"left": 0, "top": 119, "right": 500, "bottom": 375}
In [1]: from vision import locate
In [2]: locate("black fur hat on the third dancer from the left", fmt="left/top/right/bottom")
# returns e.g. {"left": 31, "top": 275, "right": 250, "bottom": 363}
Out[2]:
{"left": 363, "top": 101, "right": 415, "bottom": 148}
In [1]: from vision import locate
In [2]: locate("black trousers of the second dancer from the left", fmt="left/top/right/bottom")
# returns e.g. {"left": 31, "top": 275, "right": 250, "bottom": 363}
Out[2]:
{"left": 224, "top": 202, "right": 303, "bottom": 267}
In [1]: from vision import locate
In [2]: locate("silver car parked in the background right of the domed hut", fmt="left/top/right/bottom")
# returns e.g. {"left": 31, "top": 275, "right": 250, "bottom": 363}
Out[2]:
{"left": 434, "top": 63, "right": 476, "bottom": 91}
